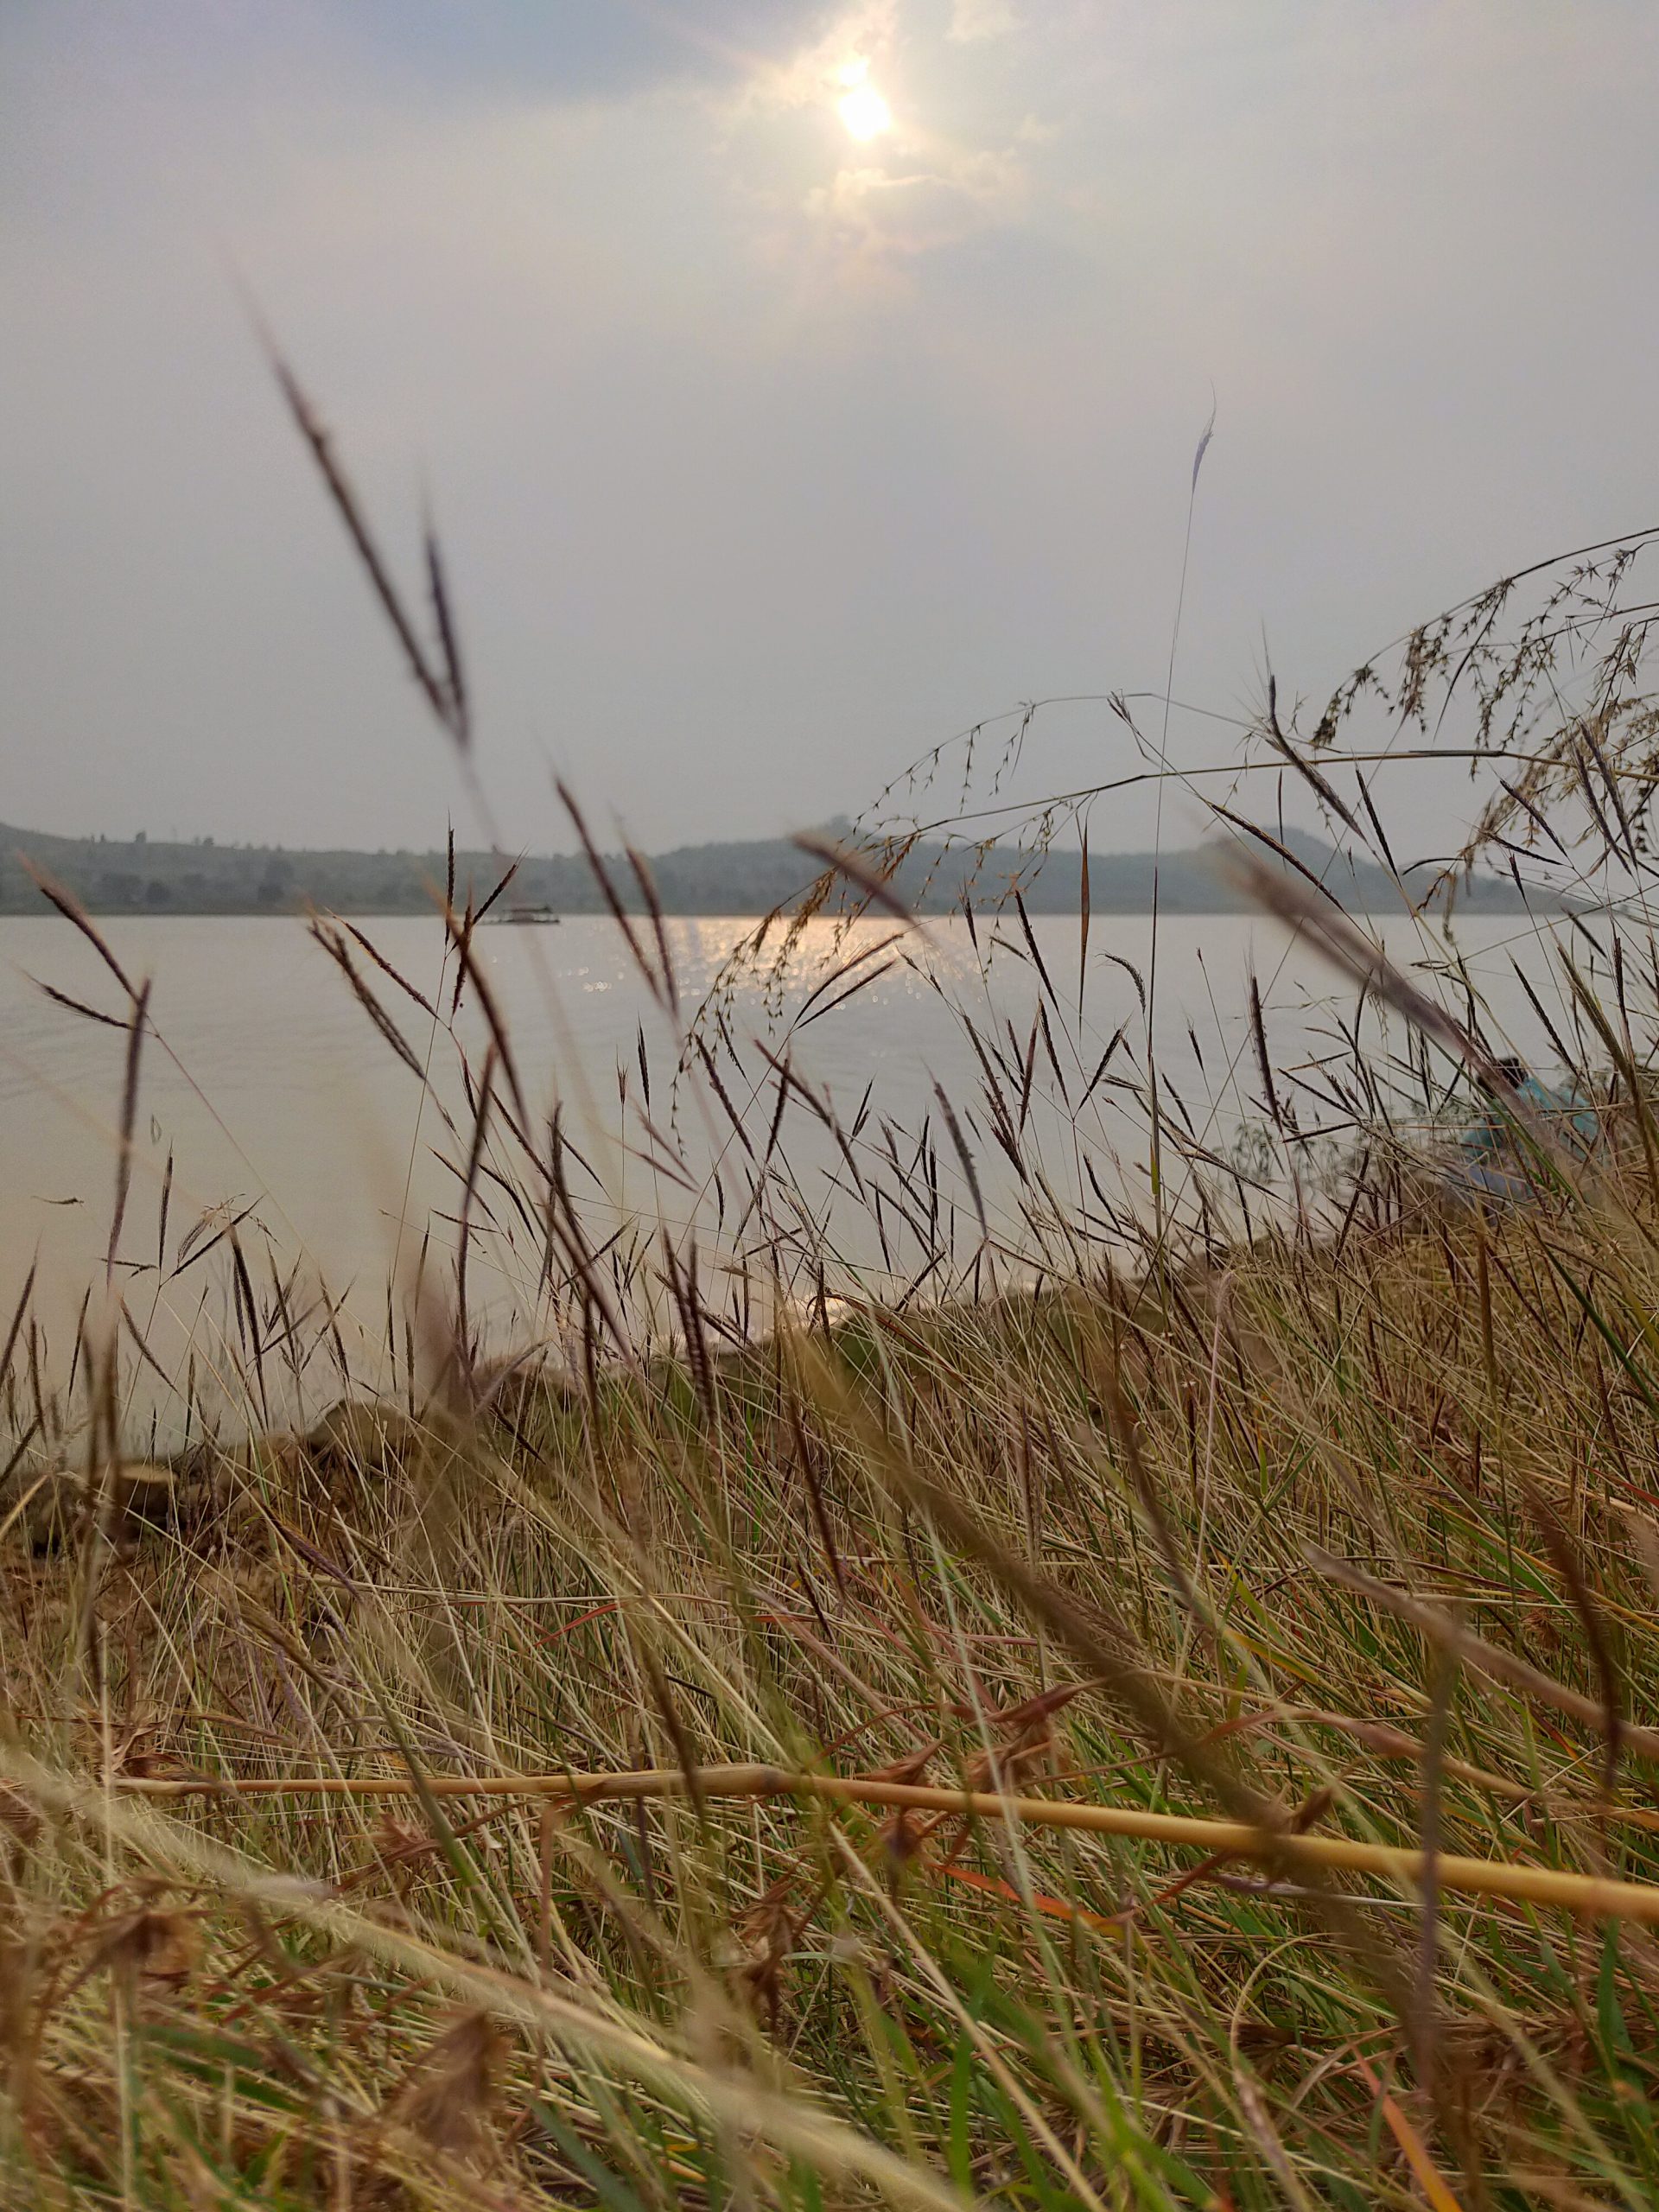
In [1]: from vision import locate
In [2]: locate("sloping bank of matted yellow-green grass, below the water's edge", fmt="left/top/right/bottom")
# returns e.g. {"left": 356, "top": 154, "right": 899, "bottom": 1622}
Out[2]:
{"left": 3, "top": 1106, "right": 1659, "bottom": 2205}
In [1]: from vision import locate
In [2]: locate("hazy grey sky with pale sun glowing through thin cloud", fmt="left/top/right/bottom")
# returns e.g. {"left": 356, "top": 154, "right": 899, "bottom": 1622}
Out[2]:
{"left": 0, "top": 0, "right": 1659, "bottom": 847}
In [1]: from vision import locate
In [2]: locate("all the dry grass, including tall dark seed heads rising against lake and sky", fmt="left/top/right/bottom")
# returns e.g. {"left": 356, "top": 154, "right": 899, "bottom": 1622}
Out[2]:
{"left": 0, "top": 407, "right": 1659, "bottom": 2212}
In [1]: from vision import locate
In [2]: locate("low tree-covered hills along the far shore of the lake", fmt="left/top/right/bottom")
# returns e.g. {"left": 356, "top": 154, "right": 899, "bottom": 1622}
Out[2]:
{"left": 0, "top": 823, "right": 1548, "bottom": 913}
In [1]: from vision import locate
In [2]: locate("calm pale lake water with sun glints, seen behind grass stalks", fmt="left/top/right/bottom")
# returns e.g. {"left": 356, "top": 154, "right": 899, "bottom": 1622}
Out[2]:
{"left": 0, "top": 916, "right": 1601, "bottom": 1407}
